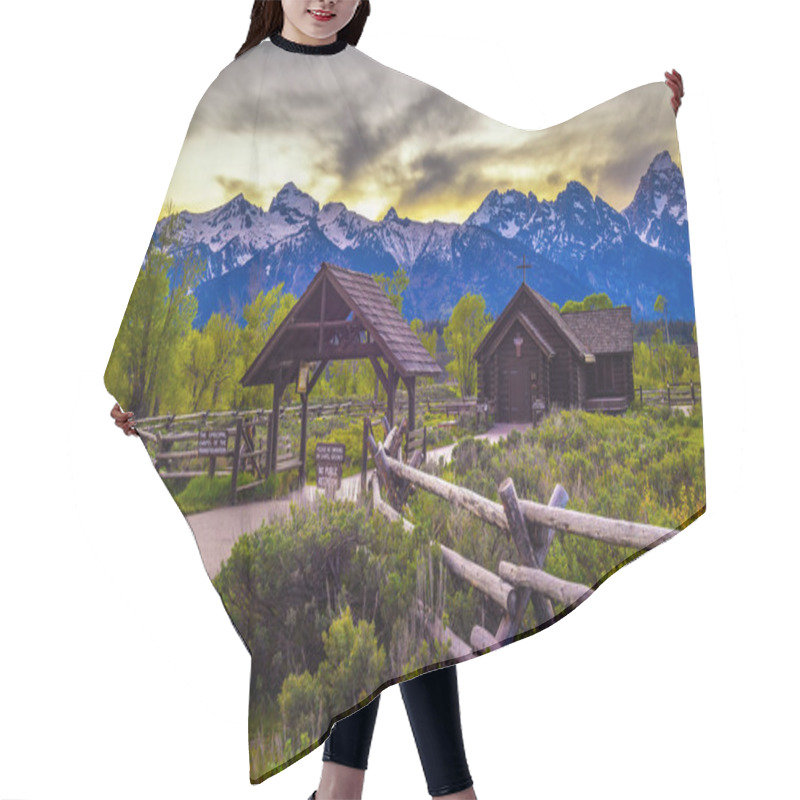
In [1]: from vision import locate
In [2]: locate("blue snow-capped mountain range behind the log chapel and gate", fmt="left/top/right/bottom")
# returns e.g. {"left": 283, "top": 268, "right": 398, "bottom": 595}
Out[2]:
{"left": 155, "top": 151, "right": 694, "bottom": 327}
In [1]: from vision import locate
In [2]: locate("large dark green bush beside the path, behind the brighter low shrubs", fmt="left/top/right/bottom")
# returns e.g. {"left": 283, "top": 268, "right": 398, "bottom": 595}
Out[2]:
{"left": 209, "top": 497, "right": 428, "bottom": 736}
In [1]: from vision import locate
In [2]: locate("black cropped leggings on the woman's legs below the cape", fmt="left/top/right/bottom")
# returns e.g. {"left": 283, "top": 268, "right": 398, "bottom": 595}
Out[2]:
{"left": 322, "top": 664, "right": 472, "bottom": 797}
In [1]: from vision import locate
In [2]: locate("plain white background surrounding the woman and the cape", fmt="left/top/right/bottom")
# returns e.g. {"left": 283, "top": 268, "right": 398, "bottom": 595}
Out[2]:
{"left": 0, "top": 0, "right": 798, "bottom": 800}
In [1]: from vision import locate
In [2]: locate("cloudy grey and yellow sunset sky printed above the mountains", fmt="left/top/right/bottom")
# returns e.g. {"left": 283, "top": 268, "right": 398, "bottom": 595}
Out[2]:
{"left": 162, "top": 40, "right": 680, "bottom": 222}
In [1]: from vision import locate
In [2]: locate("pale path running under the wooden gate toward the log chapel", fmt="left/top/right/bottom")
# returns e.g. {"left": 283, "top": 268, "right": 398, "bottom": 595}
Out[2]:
{"left": 186, "top": 423, "right": 530, "bottom": 578}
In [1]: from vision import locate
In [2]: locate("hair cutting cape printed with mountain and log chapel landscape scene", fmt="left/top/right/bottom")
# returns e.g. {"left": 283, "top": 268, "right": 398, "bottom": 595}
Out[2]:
{"left": 105, "top": 31, "right": 705, "bottom": 783}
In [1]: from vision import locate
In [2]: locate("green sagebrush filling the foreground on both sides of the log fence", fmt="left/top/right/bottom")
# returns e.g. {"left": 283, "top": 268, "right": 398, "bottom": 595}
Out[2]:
{"left": 215, "top": 408, "right": 705, "bottom": 776}
